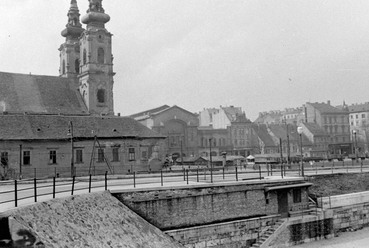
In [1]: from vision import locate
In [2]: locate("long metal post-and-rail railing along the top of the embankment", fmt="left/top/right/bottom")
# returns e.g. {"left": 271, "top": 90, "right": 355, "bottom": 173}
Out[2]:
{"left": 0, "top": 161, "right": 369, "bottom": 211}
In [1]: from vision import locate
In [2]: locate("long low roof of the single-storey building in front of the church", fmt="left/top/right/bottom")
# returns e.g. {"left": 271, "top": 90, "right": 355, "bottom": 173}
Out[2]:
{"left": 0, "top": 115, "right": 165, "bottom": 140}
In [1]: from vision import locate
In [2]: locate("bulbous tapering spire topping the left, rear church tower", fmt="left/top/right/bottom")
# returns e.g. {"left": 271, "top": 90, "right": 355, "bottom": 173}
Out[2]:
{"left": 61, "top": 0, "right": 84, "bottom": 39}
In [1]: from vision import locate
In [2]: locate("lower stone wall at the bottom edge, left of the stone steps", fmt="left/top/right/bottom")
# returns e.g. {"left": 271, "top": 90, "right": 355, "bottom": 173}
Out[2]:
{"left": 166, "top": 216, "right": 279, "bottom": 248}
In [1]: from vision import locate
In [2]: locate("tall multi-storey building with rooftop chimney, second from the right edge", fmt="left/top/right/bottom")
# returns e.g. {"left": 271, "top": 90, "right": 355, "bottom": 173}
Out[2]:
{"left": 305, "top": 101, "right": 352, "bottom": 157}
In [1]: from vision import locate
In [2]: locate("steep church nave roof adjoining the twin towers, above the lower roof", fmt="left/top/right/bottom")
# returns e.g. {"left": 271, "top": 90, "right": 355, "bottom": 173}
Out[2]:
{"left": 0, "top": 72, "right": 88, "bottom": 115}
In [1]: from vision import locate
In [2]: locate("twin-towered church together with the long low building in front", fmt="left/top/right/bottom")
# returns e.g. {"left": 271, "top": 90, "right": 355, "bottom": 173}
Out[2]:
{"left": 0, "top": 0, "right": 165, "bottom": 178}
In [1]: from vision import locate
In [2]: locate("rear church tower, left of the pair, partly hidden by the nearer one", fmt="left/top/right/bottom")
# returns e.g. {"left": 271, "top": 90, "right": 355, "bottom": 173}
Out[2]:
{"left": 59, "top": 0, "right": 84, "bottom": 78}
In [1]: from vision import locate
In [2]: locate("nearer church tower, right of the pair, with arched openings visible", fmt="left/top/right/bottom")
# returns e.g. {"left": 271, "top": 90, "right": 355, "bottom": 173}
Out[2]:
{"left": 78, "top": 0, "right": 115, "bottom": 115}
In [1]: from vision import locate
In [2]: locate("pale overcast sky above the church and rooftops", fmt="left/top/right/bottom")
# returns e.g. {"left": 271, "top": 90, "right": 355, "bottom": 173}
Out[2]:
{"left": 0, "top": 0, "right": 369, "bottom": 120}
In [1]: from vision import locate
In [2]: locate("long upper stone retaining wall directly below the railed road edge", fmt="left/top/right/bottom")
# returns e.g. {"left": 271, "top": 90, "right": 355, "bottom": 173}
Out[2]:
{"left": 113, "top": 180, "right": 306, "bottom": 230}
